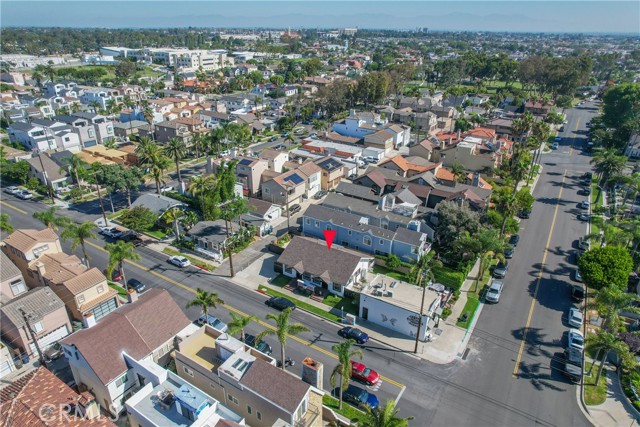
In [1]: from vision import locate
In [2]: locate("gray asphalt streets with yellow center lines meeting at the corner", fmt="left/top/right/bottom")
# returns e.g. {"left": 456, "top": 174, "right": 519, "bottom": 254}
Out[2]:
{"left": 0, "top": 109, "right": 594, "bottom": 426}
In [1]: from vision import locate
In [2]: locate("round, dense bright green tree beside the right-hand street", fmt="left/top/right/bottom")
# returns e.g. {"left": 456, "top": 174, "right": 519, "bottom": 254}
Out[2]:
{"left": 578, "top": 246, "right": 633, "bottom": 291}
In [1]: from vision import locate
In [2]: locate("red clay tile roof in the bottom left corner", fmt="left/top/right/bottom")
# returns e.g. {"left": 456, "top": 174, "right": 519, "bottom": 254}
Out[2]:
{"left": 0, "top": 366, "right": 116, "bottom": 427}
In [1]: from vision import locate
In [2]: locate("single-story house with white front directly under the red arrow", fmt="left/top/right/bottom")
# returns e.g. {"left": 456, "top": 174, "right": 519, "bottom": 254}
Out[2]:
{"left": 274, "top": 236, "right": 373, "bottom": 296}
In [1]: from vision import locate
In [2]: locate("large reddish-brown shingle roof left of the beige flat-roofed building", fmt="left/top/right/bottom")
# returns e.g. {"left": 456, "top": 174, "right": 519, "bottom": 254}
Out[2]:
{"left": 61, "top": 288, "right": 190, "bottom": 384}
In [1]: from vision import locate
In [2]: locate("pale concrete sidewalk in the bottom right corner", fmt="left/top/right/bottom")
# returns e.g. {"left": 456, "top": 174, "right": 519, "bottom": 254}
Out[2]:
{"left": 578, "top": 365, "right": 640, "bottom": 427}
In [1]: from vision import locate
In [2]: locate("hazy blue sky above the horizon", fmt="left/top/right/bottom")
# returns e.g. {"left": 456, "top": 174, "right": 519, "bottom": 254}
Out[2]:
{"left": 0, "top": 0, "right": 640, "bottom": 35}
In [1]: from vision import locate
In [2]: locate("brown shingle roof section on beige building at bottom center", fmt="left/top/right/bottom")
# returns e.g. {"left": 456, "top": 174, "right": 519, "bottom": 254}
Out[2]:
{"left": 240, "top": 359, "right": 311, "bottom": 413}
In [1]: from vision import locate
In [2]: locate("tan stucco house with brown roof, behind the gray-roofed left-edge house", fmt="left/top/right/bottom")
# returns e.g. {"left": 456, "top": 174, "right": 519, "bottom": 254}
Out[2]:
{"left": 29, "top": 252, "right": 119, "bottom": 321}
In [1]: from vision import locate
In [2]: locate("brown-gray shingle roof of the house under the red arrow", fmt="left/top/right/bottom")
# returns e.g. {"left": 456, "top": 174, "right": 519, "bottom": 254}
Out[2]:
{"left": 278, "top": 236, "right": 370, "bottom": 285}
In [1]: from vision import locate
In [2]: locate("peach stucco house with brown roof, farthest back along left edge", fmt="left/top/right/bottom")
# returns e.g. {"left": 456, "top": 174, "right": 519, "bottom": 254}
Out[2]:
{"left": 2, "top": 228, "right": 62, "bottom": 290}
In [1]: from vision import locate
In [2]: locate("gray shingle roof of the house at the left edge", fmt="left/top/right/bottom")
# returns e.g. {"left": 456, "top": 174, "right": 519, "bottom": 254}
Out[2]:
{"left": 2, "top": 286, "right": 64, "bottom": 328}
